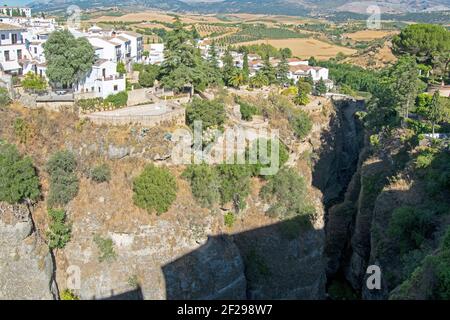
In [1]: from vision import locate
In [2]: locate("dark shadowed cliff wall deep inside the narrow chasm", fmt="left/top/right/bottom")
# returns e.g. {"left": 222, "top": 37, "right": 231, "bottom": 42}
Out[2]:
{"left": 313, "top": 100, "right": 365, "bottom": 277}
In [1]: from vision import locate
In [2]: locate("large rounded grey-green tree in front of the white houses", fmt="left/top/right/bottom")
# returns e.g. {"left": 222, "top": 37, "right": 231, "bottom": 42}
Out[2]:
{"left": 43, "top": 30, "right": 95, "bottom": 87}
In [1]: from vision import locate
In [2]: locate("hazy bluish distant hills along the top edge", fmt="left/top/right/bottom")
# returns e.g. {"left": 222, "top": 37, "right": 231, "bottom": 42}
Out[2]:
{"left": 29, "top": 0, "right": 450, "bottom": 16}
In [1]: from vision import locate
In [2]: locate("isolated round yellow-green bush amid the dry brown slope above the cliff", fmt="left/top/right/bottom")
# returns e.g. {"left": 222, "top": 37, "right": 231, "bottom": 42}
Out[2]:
{"left": 133, "top": 164, "right": 177, "bottom": 215}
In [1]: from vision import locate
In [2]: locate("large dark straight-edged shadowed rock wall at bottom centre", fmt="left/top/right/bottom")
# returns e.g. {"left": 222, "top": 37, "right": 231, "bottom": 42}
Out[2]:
{"left": 162, "top": 220, "right": 326, "bottom": 299}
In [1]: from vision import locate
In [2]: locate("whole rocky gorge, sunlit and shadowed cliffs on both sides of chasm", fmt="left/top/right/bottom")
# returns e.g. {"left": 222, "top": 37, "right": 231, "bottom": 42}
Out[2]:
{"left": 0, "top": 100, "right": 436, "bottom": 299}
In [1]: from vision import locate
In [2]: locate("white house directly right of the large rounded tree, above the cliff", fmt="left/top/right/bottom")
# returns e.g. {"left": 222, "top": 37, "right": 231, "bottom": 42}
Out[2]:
{"left": 74, "top": 59, "right": 126, "bottom": 98}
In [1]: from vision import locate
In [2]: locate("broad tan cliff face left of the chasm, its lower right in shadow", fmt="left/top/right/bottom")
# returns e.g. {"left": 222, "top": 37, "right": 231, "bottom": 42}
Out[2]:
{"left": 0, "top": 99, "right": 338, "bottom": 299}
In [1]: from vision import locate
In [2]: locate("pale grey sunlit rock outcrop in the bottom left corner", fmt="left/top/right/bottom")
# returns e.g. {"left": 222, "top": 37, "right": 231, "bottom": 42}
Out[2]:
{"left": 0, "top": 203, "right": 58, "bottom": 300}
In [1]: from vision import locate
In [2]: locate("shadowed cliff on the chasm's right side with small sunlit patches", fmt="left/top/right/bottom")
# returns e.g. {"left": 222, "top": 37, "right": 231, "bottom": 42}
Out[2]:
{"left": 326, "top": 129, "right": 448, "bottom": 299}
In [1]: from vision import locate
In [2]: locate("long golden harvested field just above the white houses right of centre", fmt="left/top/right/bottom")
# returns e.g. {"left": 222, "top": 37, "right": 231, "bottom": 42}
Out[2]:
{"left": 236, "top": 39, "right": 356, "bottom": 60}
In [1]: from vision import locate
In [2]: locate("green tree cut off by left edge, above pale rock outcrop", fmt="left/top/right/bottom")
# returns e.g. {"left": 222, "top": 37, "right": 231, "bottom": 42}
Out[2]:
{"left": 0, "top": 141, "right": 41, "bottom": 204}
